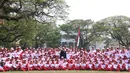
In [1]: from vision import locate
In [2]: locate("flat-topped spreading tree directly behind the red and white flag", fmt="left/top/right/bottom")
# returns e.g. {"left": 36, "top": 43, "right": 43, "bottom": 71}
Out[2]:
{"left": 61, "top": 19, "right": 97, "bottom": 48}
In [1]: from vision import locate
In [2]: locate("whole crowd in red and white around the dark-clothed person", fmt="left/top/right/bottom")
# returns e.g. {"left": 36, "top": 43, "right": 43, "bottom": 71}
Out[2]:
{"left": 0, "top": 47, "right": 130, "bottom": 71}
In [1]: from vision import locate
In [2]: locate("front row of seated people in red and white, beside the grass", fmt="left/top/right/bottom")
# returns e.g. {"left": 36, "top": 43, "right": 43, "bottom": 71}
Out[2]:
{"left": 0, "top": 59, "right": 130, "bottom": 71}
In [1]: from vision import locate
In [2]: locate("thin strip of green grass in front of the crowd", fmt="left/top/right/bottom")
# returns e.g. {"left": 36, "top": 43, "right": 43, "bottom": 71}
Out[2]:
{"left": 3, "top": 70, "right": 130, "bottom": 73}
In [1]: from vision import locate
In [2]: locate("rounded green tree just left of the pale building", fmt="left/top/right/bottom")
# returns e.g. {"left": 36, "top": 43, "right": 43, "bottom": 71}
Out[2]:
{"left": 35, "top": 24, "right": 60, "bottom": 47}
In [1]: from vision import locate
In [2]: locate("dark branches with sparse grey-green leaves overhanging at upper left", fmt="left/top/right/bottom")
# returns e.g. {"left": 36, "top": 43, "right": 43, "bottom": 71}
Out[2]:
{"left": 0, "top": 0, "right": 68, "bottom": 22}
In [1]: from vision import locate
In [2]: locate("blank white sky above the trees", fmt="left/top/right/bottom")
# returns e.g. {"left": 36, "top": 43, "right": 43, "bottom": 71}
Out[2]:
{"left": 65, "top": 0, "right": 130, "bottom": 21}
